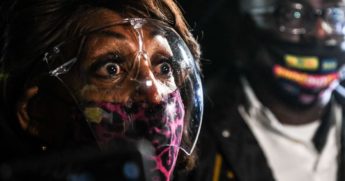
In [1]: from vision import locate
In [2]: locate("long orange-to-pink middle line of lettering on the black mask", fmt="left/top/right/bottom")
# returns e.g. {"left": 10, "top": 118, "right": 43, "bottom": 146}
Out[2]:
{"left": 273, "top": 65, "right": 339, "bottom": 88}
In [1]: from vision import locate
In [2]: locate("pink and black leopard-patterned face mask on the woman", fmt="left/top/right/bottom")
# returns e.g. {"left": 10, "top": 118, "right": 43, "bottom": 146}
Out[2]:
{"left": 84, "top": 91, "right": 185, "bottom": 180}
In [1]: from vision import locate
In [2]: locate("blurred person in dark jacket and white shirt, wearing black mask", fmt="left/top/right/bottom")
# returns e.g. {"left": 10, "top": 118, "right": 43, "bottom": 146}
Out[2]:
{"left": 176, "top": 0, "right": 345, "bottom": 181}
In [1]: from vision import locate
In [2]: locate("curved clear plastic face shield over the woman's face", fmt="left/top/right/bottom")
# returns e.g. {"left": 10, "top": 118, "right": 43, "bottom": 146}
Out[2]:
{"left": 38, "top": 18, "right": 203, "bottom": 158}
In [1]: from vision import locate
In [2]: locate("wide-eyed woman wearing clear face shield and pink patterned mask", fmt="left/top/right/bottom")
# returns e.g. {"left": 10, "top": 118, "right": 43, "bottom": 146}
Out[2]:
{"left": 1, "top": 0, "right": 203, "bottom": 180}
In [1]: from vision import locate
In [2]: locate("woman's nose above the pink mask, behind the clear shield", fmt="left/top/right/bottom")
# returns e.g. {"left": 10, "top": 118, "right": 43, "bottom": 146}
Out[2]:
{"left": 134, "top": 55, "right": 162, "bottom": 104}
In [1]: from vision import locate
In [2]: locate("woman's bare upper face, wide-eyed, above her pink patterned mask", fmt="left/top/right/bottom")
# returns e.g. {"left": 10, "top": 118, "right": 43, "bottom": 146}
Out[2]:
{"left": 70, "top": 10, "right": 177, "bottom": 104}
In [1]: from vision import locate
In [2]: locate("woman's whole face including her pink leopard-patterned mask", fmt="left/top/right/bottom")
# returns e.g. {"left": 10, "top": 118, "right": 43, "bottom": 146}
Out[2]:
{"left": 62, "top": 10, "right": 185, "bottom": 180}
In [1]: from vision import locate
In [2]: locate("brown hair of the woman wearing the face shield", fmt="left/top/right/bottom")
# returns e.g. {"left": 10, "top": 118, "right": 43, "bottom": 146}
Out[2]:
{"left": 0, "top": 0, "right": 200, "bottom": 168}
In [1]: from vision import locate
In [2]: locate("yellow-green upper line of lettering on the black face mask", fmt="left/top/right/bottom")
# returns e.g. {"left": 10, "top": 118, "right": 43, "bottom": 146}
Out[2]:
{"left": 284, "top": 55, "right": 319, "bottom": 70}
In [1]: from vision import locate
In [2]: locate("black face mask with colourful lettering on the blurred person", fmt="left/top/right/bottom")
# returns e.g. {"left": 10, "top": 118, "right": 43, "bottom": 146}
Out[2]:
{"left": 257, "top": 39, "right": 345, "bottom": 107}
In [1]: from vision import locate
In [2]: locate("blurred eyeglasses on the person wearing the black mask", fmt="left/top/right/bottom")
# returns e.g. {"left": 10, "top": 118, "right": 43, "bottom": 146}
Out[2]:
{"left": 272, "top": 2, "right": 345, "bottom": 35}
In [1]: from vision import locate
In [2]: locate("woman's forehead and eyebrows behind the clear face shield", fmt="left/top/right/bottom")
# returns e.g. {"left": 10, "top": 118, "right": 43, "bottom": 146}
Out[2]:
{"left": 79, "top": 20, "right": 172, "bottom": 62}
